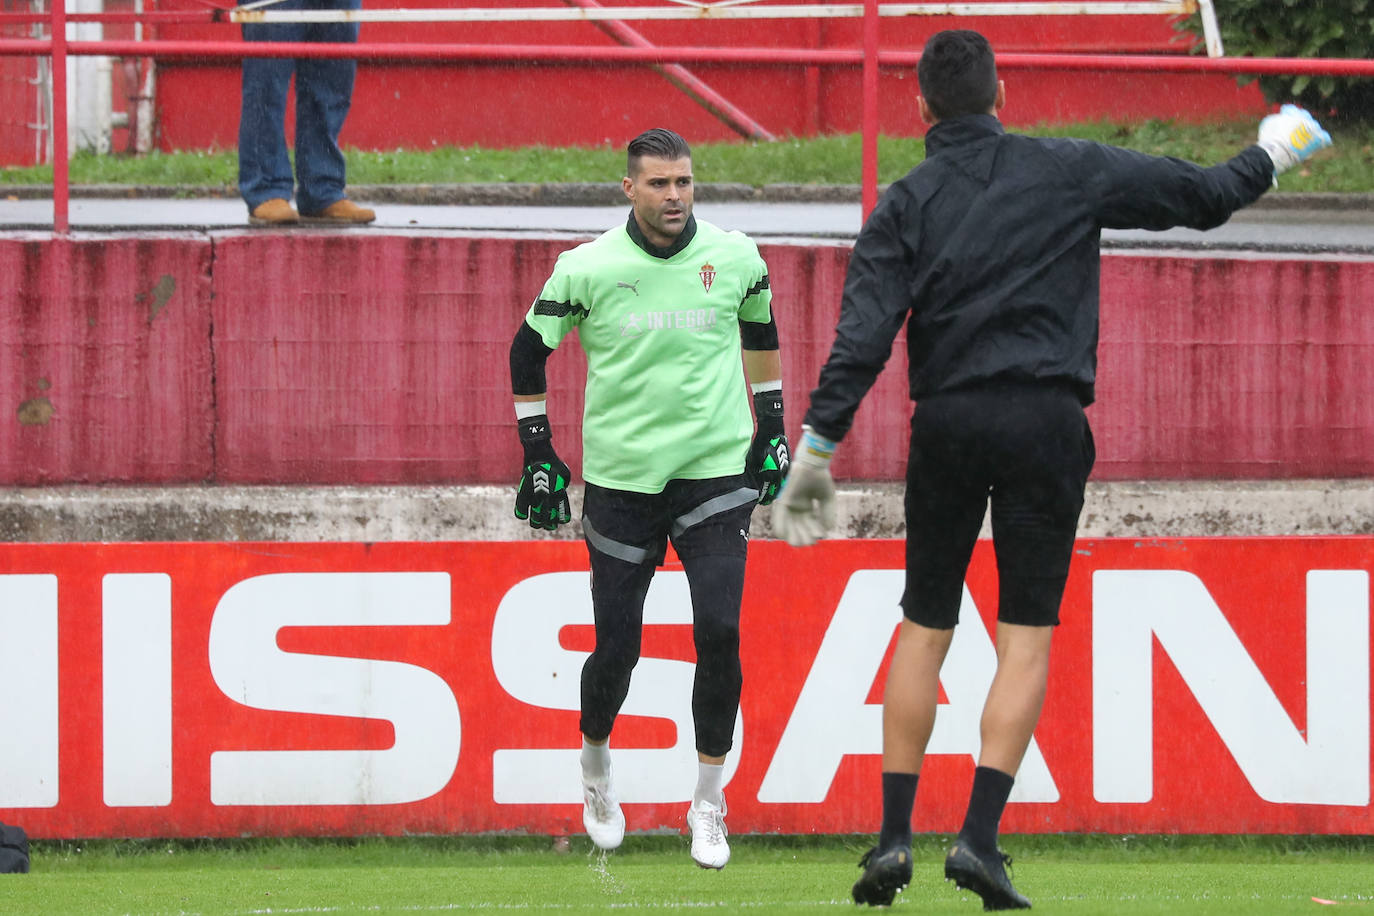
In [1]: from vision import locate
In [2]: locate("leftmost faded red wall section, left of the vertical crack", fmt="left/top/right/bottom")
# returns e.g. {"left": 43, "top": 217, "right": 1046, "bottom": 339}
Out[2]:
{"left": 0, "top": 235, "right": 214, "bottom": 485}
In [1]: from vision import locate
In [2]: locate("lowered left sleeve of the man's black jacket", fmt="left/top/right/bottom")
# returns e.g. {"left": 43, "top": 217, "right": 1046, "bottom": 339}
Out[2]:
{"left": 804, "top": 188, "right": 919, "bottom": 442}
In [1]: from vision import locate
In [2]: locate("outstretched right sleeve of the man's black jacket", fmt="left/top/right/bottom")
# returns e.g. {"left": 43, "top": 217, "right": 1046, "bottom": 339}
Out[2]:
{"left": 1070, "top": 143, "right": 1274, "bottom": 229}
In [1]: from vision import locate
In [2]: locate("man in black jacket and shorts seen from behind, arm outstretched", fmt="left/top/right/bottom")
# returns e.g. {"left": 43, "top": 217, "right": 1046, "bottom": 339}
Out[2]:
{"left": 772, "top": 30, "right": 1330, "bottom": 909}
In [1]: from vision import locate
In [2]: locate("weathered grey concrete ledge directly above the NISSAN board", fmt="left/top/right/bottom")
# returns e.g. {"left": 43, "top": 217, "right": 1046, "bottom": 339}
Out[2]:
{"left": 0, "top": 479, "right": 1374, "bottom": 542}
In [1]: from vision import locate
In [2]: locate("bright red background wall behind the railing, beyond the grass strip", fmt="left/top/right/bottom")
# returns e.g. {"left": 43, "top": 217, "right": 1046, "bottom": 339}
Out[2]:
{"left": 144, "top": 0, "right": 1264, "bottom": 153}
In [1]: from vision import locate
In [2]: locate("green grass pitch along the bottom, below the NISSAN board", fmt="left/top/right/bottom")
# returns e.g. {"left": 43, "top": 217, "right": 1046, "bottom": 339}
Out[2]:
{"left": 10, "top": 835, "right": 1374, "bottom": 916}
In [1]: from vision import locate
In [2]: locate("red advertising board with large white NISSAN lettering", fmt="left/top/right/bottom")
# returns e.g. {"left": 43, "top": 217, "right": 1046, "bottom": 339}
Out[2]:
{"left": 0, "top": 537, "right": 1374, "bottom": 838}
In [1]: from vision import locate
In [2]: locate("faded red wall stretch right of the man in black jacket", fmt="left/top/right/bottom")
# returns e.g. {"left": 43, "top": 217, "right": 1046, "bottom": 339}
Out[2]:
{"left": 1092, "top": 257, "right": 1374, "bottom": 479}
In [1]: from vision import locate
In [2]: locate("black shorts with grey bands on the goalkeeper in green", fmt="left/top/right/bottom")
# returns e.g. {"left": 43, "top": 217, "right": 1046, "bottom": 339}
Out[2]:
{"left": 583, "top": 475, "right": 758, "bottom": 566}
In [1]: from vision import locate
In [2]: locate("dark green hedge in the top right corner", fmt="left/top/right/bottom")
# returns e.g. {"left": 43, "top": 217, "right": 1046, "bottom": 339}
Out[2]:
{"left": 1179, "top": 0, "right": 1374, "bottom": 122}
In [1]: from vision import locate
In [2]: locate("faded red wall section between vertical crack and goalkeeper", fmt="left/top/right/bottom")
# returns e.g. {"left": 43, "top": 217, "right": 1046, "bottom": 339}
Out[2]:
{"left": 214, "top": 235, "right": 581, "bottom": 483}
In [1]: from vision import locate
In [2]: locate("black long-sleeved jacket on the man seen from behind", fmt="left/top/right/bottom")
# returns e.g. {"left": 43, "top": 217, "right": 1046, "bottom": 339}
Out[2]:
{"left": 805, "top": 114, "right": 1274, "bottom": 439}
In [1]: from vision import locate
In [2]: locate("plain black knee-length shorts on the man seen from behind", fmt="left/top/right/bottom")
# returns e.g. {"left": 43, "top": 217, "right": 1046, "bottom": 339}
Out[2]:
{"left": 901, "top": 382, "right": 1095, "bottom": 629}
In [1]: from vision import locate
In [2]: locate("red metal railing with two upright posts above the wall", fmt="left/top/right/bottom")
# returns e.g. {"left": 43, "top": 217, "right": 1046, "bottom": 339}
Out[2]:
{"left": 0, "top": 0, "right": 1374, "bottom": 233}
